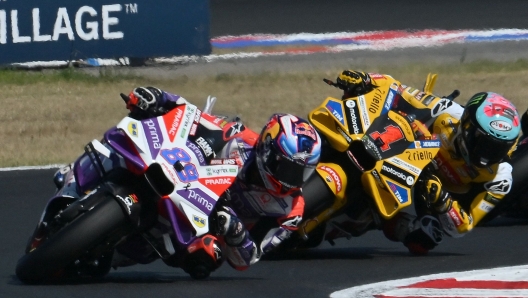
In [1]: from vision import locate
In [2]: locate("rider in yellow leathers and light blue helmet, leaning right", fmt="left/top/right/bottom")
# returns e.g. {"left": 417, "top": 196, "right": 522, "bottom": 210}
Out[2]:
{"left": 327, "top": 70, "right": 521, "bottom": 254}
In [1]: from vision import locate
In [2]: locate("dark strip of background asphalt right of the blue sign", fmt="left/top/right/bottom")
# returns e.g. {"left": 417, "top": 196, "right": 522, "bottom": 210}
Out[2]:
{"left": 210, "top": 0, "right": 528, "bottom": 37}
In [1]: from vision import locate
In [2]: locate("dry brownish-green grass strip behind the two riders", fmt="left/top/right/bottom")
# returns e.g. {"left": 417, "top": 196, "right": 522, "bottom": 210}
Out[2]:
{"left": 0, "top": 60, "right": 528, "bottom": 167}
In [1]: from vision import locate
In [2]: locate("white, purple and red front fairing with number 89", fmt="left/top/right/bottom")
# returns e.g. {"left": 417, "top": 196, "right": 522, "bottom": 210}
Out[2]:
{"left": 115, "top": 103, "right": 238, "bottom": 236}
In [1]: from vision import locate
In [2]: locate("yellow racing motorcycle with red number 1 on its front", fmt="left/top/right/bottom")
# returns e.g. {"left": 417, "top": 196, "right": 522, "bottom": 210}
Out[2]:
{"left": 272, "top": 74, "right": 458, "bottom": 250}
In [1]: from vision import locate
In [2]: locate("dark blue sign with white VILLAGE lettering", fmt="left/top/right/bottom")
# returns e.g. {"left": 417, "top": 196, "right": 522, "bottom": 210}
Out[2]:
{"left": 0, "top": 0, "right": 211, "bottom": 64}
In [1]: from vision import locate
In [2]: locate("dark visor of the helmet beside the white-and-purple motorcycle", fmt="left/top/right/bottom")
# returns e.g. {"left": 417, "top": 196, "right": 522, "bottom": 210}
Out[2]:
{"left": 263, "top": 150, "right": 315, "bottom": 189}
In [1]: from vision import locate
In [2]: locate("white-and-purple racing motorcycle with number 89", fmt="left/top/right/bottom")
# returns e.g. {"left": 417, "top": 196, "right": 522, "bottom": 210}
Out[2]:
{"left": 16, "top": 94, "right": 238, "bottom": 284}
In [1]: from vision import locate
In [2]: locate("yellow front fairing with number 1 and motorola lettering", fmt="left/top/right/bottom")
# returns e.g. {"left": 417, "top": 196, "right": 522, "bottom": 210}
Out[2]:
{"left": 308, "top": 77, "right": 440, "bottom": 219}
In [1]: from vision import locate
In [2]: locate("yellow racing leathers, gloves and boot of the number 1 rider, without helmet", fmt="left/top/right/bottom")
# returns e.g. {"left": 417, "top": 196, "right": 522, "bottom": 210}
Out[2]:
{"left": 338, "top": 70, "right": 515, "bottom": 254}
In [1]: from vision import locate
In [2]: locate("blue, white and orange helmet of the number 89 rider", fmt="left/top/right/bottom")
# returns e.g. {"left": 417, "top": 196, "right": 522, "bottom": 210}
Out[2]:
{"left": 256, "top": 114, "right": 321, "bottom": 197}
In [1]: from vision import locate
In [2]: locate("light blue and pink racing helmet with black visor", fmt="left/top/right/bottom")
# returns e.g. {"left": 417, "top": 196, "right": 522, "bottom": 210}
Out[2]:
{"left": 457, "top": 92, "right": 521, "bottom": 168}
